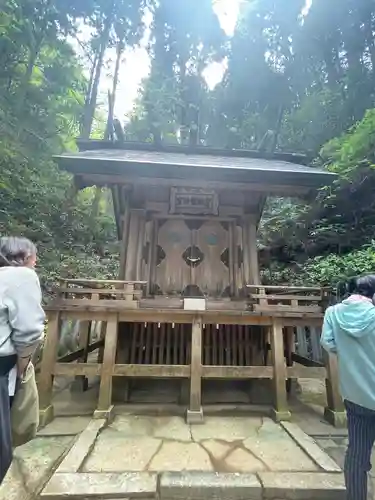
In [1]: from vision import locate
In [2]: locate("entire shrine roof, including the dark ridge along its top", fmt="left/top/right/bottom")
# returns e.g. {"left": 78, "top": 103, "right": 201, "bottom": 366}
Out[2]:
{"left": 55, "top": 141, "right": 335, "bottom": 188}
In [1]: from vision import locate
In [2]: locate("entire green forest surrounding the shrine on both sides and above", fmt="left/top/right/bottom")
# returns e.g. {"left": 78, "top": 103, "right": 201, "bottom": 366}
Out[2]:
{"left": 0, "top": 0, "right": 375, "bottom": 292}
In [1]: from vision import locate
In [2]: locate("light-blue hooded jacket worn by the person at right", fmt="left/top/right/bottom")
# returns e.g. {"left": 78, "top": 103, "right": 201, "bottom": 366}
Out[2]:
{"left": 321, "top": 298, "right": 375, "bottom": 410}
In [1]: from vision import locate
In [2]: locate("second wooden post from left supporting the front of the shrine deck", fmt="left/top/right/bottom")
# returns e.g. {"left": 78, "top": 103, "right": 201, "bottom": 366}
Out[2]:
{"left": 94, "top": 314, "right": 118, "bottom": 419}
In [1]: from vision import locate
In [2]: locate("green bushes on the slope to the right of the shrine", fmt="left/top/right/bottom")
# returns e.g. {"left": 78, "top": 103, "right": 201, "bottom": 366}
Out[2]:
{"left": 261, "top": 109, "right": 375, "bottom": 284}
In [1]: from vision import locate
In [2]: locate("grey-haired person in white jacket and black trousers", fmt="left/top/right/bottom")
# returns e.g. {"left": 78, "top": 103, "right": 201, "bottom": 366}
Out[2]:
{"left": 0, "top": 237, "right": 45, "bottom": 484}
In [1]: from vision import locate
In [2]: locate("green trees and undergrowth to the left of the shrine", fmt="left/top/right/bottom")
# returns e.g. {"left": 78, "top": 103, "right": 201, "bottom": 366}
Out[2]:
{"left": 0, "top": 0, "right": 118, "bottom": 296}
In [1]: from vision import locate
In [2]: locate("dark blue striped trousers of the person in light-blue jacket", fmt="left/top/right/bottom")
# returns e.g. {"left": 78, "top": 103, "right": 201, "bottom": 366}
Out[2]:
{"left": 344, "top": 401, "right": 375, "bottom": 500}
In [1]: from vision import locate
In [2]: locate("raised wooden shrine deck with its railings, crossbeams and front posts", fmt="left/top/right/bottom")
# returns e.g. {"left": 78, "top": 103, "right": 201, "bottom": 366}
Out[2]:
{"left": 39, "top": 279, "right": 342, "bottom": 423}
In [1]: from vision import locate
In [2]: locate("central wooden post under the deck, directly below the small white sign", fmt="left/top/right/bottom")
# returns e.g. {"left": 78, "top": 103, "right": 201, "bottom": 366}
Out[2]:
{"left": 186, "top": 319, "right": 203, "bottom": 424}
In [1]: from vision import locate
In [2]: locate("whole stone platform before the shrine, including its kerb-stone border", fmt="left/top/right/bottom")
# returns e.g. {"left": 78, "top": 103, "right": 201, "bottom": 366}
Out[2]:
{"left": 24, "top": 413, "right": 345, "bottom": 500}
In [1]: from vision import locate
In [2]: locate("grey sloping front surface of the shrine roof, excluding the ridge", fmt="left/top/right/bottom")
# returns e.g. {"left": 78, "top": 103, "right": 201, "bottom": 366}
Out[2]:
{"left": 55, "top": 149, "right": 335, "bottom": 187}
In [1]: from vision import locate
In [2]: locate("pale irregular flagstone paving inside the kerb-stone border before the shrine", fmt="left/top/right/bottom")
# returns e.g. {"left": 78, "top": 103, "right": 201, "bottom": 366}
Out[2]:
{"left": 83, "top": 415, "right": 324, "bottom": 473}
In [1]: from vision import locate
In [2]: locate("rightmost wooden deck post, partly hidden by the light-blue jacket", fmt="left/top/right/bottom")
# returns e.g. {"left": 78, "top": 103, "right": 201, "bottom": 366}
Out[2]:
{"left": 323, "top": 351, "right": 346, "bottom": 427}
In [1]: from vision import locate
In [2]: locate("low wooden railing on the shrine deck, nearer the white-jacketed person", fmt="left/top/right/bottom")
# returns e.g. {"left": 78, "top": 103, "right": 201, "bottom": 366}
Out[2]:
{"left": 53, "top": 279, "right": 147, "bottom": 309}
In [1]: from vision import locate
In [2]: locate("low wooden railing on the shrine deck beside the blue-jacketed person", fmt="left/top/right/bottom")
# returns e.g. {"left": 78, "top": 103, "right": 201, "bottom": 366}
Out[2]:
{"left": 247, "top": 285, "right": 329, "bottom": 313}
